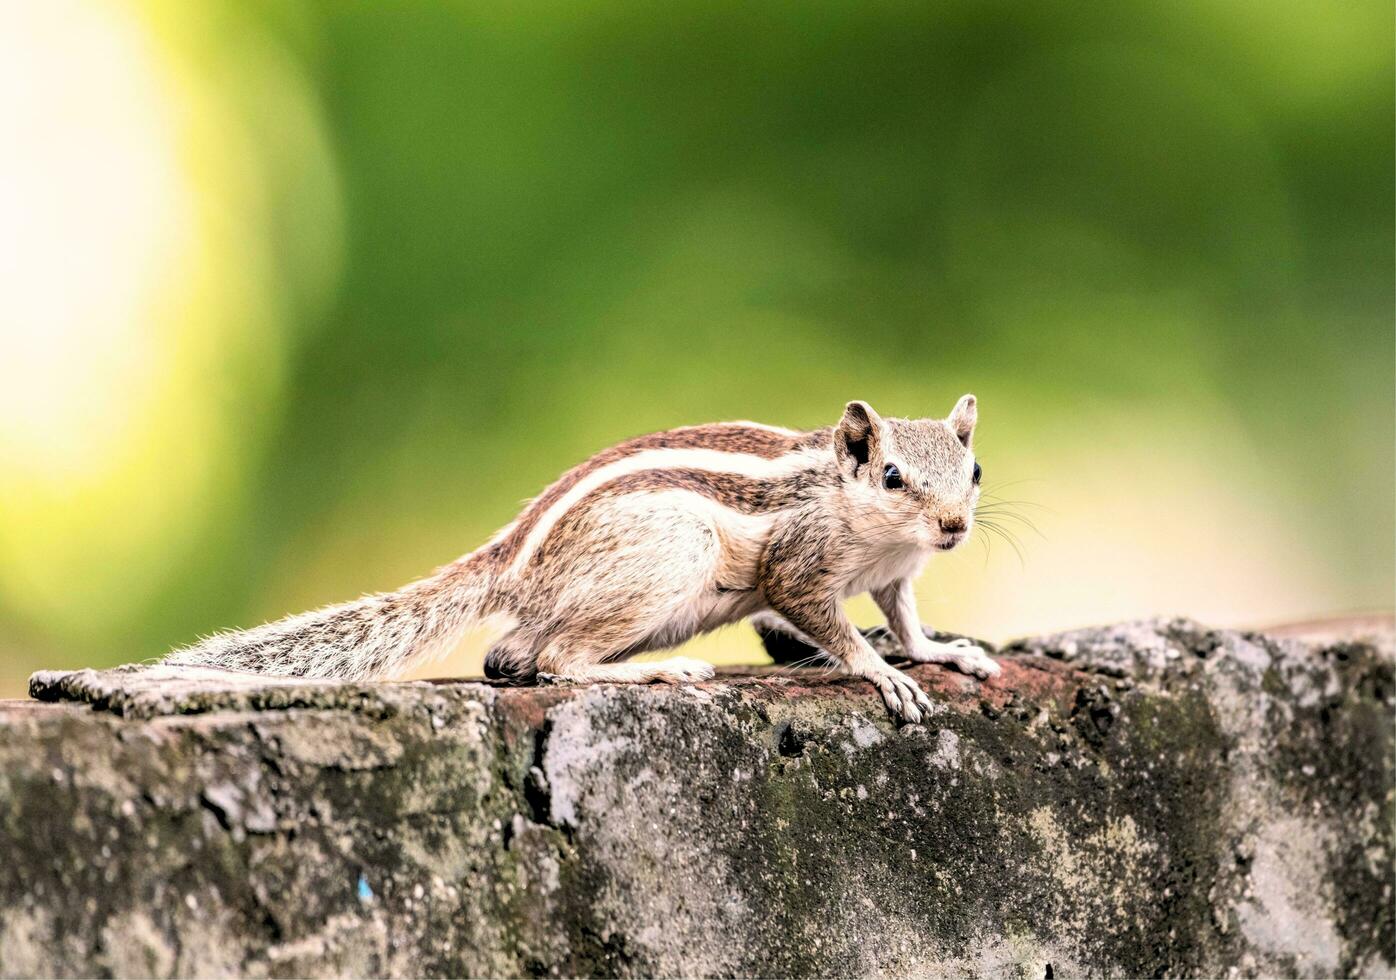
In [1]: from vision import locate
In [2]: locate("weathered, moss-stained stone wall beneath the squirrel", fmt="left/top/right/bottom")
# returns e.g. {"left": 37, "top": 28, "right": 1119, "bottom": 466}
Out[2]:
{"left": 0, "top": 621, "right": 1396, "bottom": 977}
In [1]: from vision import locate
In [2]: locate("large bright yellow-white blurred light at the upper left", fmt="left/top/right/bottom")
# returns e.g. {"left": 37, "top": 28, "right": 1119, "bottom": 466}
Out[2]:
{"left": 0, "top": 1, "right": 336, "bottom": 653}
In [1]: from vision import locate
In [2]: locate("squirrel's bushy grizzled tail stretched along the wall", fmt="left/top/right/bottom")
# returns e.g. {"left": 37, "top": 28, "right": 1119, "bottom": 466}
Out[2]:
{"left": 163, "top": 557, "right": 489, "bottom": 680}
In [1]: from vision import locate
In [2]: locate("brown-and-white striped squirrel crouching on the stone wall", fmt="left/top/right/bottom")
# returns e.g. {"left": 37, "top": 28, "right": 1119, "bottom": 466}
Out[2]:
{"left": 165, "top": 395, "right": 1000, "bottom": 722}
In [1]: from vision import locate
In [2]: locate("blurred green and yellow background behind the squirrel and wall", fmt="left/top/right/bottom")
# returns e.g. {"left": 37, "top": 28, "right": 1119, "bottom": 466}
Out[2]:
{"left": 0, "top": 0, "right": 1396, "bottom": 695}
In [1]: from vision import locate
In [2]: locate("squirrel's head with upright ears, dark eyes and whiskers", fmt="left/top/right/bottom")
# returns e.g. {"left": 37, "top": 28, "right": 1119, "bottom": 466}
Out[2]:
{"left": 833, "top": 395, "right": 980, "bottom": 551}
